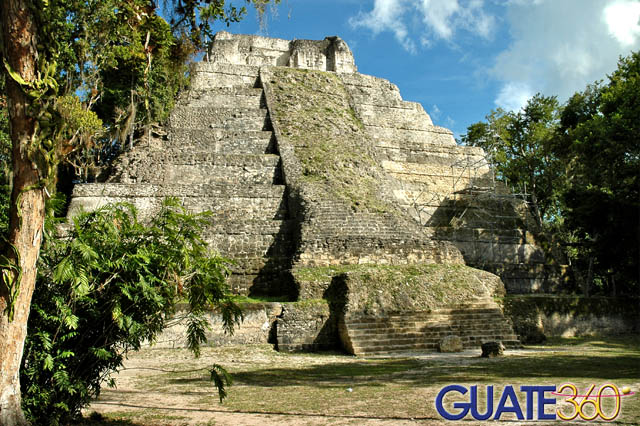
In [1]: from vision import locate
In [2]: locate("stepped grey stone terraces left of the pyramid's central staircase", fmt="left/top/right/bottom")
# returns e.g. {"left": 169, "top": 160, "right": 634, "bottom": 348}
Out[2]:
{"left": 70, "top": 76, "right": 293, "bottom": 295}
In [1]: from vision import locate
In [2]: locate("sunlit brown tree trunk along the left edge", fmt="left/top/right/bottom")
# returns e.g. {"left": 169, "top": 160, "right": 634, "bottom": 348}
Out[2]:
{"left": 0, "top": 0, "right": 45, "bottom": 426}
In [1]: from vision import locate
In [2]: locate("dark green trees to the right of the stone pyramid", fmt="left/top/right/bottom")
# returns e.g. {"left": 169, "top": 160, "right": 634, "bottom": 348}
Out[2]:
{"left": 463, "top": 52, "right": 640, "bottom": 294}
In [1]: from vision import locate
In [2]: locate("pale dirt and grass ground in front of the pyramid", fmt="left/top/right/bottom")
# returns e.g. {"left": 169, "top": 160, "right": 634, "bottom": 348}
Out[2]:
{"left": 85, "top": 345, "right": 640, "bottom": 426}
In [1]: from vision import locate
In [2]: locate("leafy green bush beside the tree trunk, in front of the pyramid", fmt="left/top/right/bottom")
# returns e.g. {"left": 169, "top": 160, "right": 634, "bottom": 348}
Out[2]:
{"left": 21, "top": 200, "right": 241, "bottom": 424}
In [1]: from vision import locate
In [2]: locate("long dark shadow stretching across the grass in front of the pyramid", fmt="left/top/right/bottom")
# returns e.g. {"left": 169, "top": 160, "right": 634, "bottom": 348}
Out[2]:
{"left": 191, "top": 348, "right": 640, "bottom": 388}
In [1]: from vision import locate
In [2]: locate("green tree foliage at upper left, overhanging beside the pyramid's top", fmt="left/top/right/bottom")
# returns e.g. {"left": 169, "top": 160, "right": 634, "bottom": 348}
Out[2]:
{"left": 0, "top": 0, "right": 279, "bottom": 186}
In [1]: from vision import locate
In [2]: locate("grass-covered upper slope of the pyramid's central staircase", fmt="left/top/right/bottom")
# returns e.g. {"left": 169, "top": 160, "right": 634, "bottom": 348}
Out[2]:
{"left": 267, "top": 67, "right": 395, "bottom": 213}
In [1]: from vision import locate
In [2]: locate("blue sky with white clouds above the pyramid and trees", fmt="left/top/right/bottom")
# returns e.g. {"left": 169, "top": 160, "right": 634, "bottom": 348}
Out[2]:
{"left": 225, "top": 0, "right": 640, "bottom": 136}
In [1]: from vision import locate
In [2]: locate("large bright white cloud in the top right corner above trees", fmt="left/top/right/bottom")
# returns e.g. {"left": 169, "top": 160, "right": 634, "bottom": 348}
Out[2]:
{"left": 490, "top": 0, "right": 640, "bottom": 109}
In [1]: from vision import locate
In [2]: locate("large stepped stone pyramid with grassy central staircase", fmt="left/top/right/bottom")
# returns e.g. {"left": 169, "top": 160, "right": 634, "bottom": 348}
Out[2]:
{"left": 63, "top": 32, "right": 553, "bottom": 354}
